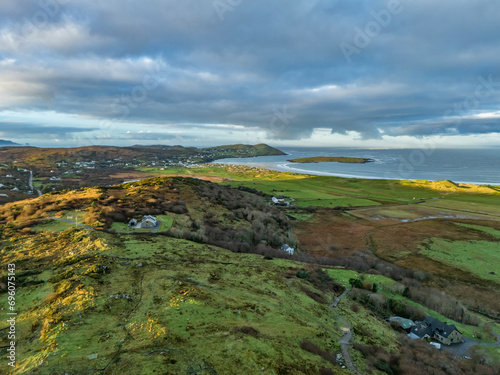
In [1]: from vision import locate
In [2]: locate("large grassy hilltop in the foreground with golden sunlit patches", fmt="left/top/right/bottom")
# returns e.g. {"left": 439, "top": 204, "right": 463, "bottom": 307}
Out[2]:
{"left": 0, "top": 230, "right": 352, "bottom": 374}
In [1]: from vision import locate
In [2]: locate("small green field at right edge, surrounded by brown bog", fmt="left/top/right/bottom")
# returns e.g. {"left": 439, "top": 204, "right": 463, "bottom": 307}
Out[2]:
{"left": 420, "top": 239, "right": 500, "bottom": 283}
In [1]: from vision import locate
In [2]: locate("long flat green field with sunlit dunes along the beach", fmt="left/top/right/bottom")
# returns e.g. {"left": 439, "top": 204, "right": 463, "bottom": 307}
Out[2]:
{"left": 141, "top": 164, "right": 500, "bottom": 212}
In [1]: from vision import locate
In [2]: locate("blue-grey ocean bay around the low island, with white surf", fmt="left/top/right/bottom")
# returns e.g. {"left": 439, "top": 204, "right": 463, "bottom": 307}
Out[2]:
{"left": 215, "top": 147, "right": 500, "bottom": 185}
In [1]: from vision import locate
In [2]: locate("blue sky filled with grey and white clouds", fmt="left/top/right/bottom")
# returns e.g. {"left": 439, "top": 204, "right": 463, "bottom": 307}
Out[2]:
{"left": 0, "top": 0, "right": 500, "bottom": 148}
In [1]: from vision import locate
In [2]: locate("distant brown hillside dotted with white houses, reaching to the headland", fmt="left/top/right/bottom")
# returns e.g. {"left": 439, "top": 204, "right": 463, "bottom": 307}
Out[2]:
{"left": 0, "top": 144, "right": 284, "bottom": 204}
